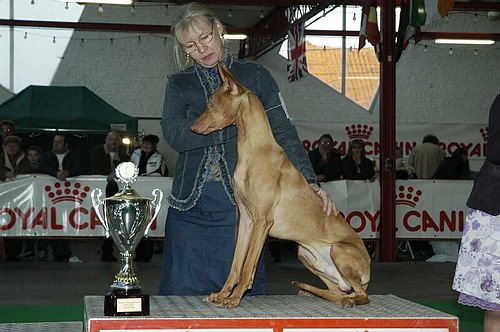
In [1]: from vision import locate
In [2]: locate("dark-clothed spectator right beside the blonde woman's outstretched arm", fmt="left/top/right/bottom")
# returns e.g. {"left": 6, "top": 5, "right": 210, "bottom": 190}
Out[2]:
{"left": 309, "top": 134, "right": 342, "bottom": 182}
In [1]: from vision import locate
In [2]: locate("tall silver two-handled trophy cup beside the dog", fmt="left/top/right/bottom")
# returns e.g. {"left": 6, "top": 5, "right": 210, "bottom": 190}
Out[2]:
{"left": 91, "top": 162, "right": 163, "bottom": 315}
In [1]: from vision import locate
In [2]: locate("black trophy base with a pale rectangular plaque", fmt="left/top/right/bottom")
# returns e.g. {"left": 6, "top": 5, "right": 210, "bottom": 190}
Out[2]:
{"left": 104, "top": 290, "right": 149, "bottom": 316}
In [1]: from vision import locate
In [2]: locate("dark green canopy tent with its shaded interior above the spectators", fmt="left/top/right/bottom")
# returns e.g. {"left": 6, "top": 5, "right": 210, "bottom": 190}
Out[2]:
{"left": 0, "top": 85, "right": 138, "bottom": 174}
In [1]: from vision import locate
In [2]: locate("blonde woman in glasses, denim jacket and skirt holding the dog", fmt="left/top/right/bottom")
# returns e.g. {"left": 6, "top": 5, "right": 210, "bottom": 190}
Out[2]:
{"left": 160, "top": 3, "right": 336, "bottom": 295}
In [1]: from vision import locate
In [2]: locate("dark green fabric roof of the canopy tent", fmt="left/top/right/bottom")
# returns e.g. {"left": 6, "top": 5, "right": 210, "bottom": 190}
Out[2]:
{"left": 0, "top": 85, "right": 137, "bottom": 136}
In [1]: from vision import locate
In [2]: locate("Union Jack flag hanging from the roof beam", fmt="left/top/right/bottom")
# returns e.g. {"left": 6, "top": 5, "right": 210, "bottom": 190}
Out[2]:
{"left": 286, "top": 22, "right": 307, "bottom": 82}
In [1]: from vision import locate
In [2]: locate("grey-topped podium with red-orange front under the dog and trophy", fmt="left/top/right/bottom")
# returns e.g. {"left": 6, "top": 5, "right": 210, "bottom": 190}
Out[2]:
{"left": 84, "top": 295, "right": 458, "bottom": 332}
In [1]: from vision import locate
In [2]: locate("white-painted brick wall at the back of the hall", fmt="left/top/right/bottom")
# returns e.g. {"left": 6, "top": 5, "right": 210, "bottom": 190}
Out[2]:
{"left": 22, "top": 6, "right": 500, "bottom": 174}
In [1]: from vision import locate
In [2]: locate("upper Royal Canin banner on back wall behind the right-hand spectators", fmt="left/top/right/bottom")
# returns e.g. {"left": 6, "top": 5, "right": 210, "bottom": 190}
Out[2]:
{"left": 294, "top": 121, "right": 488, "bottom": 171}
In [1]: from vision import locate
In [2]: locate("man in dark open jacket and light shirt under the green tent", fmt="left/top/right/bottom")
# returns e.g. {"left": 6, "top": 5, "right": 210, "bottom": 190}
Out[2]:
{"left": 38, "top": 134, "right": 83, "bottom": 262}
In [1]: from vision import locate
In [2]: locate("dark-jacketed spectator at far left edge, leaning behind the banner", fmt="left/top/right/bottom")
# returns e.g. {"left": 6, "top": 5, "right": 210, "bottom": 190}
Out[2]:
{"left": 0, "top": 136, "right": 33, "bottom": 181}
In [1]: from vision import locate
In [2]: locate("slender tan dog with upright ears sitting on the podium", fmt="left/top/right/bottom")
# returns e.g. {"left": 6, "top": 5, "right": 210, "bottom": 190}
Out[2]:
{"left": 191, "top": 65, "right": 370, "bottom": 308}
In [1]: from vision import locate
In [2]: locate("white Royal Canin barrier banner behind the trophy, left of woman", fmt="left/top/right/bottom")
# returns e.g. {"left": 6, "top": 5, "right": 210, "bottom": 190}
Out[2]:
{"left": 0, "top": 175, "right": 171, "bottom": 237}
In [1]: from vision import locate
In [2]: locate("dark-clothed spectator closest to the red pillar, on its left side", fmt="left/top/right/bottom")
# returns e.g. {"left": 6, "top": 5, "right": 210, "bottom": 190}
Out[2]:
{"left": 342, "top": 139, "right": 375, "bottom": 180}
